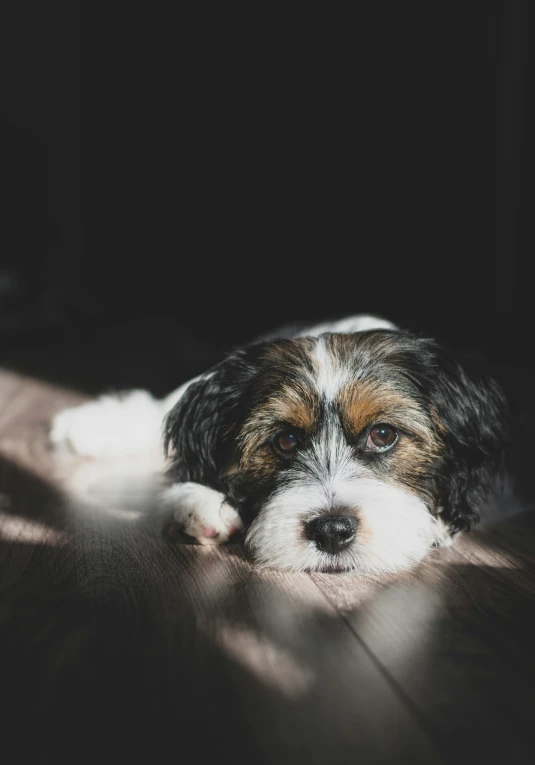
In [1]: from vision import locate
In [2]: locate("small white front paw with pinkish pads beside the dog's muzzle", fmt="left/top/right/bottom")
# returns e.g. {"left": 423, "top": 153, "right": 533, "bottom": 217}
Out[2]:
{"left": 162, "top": 483, "right": 243, "bottom": 545}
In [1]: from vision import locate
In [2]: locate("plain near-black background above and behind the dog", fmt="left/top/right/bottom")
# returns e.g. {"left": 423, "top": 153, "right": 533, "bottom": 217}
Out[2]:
{"left": 0, "top": 0, "right": 534, "bottom": 392}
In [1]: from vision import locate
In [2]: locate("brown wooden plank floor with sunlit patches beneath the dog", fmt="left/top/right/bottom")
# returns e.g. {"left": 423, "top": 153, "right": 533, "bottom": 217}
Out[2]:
{"left": 0, "top": 362, "right": 535, "bottom": 765}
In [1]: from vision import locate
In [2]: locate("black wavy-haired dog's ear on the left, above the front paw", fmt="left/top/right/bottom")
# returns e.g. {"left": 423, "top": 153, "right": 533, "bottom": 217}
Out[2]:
{"left": 164, "top": 345, "right": 260, "bottom": 488}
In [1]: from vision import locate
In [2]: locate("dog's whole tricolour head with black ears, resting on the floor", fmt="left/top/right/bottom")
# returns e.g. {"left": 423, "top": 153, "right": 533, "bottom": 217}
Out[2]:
{"left": 167, "top": 330, "right": 505, "bottom": 574}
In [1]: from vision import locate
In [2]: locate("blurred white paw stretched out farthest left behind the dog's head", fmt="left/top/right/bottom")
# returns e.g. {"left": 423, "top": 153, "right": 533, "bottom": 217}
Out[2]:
{"left": 50, "top": 390, "right": 163, "bottom": 457}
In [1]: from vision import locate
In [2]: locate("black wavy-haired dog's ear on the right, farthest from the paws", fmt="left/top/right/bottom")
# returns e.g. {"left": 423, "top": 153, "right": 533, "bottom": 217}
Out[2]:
{"left": 427, "top": 346, "right": 509, "bottom": 532}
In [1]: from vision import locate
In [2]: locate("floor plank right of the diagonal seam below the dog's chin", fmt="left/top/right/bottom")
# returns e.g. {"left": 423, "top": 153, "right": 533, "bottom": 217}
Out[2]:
{"left": 318, "top": 535, "right": 535, "bottom": 763}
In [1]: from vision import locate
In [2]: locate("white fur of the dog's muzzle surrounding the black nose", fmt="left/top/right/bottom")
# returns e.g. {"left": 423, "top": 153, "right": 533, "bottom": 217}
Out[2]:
{"left": 247, "top": 477, "right": 443, "bottom": 574}
